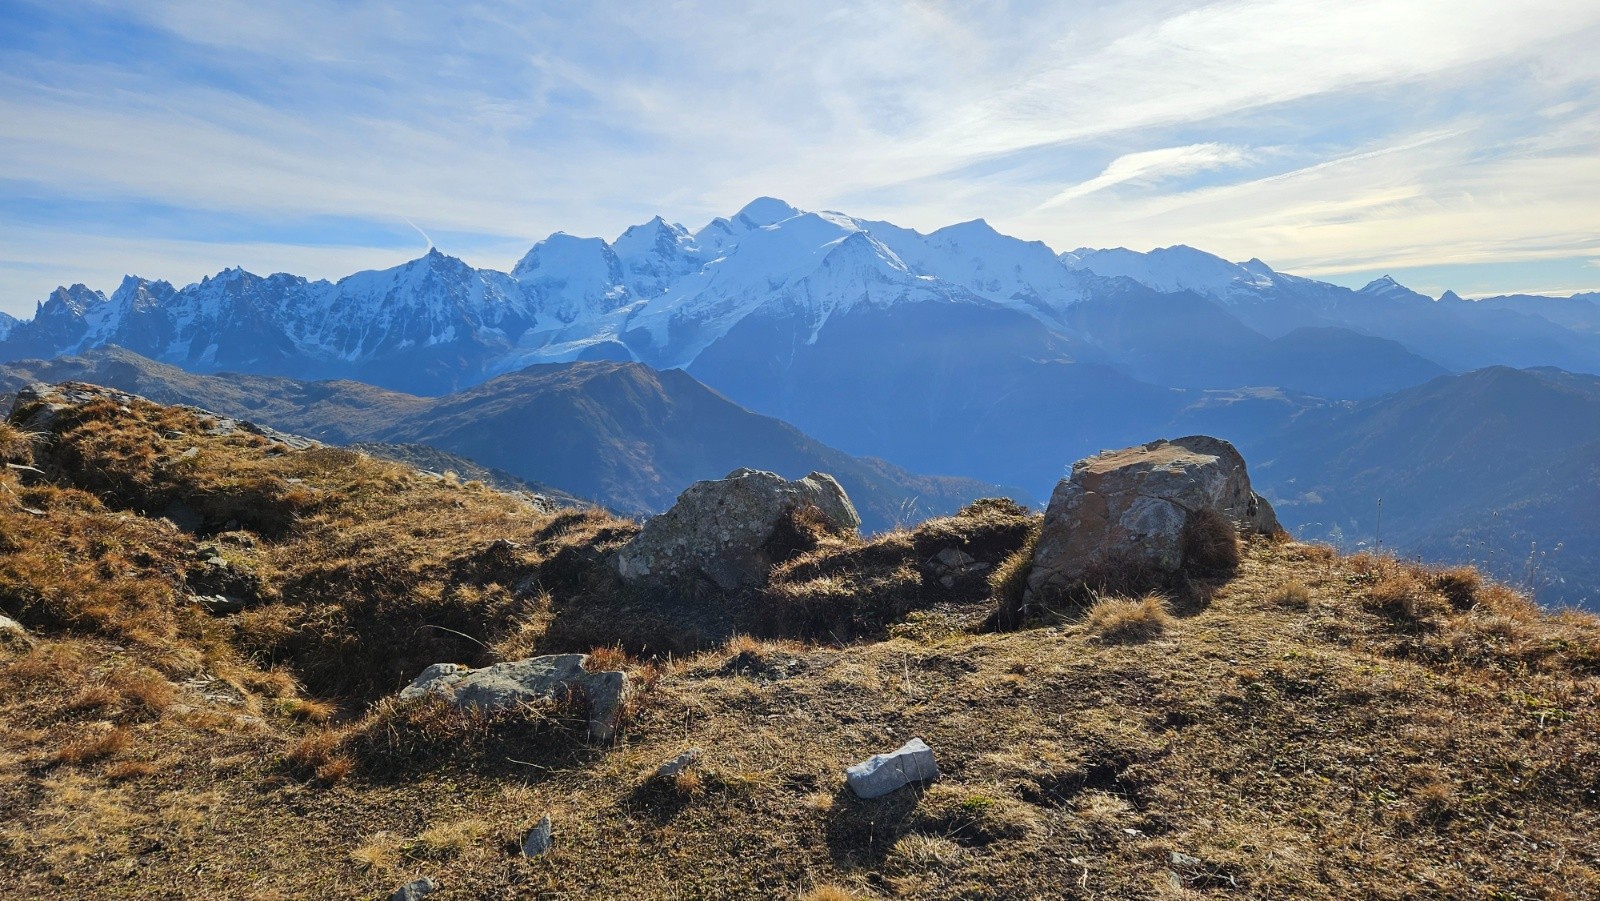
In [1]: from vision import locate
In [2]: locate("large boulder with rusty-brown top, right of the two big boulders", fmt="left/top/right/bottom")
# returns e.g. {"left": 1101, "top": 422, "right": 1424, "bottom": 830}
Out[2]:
{"left": 1027, "top": 435, "right": 1280, "bottom": 599}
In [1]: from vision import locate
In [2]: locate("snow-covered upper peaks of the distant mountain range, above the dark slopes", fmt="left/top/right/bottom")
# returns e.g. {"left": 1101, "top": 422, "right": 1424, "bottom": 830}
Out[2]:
{"left": 15, "top": 197, "right": 1600, "bottom": 390}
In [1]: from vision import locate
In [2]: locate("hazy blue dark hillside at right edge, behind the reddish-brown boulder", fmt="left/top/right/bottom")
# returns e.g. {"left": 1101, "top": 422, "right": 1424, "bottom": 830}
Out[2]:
{"left": 1246, "top": 366, "right": 1600, "bottom": 607}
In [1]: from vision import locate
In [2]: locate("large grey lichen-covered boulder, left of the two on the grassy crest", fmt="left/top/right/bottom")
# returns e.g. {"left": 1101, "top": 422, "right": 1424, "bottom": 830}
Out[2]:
{"left": 616, "top": 469, "right": 861, "bottom": 591}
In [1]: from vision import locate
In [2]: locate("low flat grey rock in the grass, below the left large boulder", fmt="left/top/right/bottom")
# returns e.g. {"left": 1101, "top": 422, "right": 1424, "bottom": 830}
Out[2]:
{"left": 400, "top": 655, "right": 629, "bottom": 741}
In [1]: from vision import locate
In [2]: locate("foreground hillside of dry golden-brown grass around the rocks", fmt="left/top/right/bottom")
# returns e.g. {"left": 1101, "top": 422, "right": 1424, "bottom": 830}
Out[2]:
{"left": 0, "top": 389, "right": 1600, "bottom": 901}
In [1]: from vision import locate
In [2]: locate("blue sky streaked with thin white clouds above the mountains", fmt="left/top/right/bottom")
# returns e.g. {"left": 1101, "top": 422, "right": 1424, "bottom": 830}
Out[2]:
{"left": 0, "top": 0, "right": 1600, "bottom": 315}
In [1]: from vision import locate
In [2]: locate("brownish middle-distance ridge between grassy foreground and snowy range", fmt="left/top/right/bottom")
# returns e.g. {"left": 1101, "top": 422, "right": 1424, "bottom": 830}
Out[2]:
{"left": 0, "top": 347, "right": 1003, "bottom": 530}
